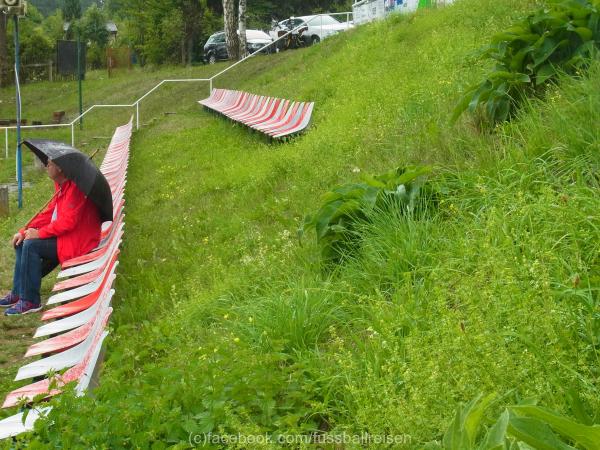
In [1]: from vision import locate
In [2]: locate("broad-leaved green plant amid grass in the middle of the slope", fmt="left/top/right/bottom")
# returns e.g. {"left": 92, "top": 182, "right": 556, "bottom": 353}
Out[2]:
{"left": 298, "top": 166, "right": 431, "bottom": 263}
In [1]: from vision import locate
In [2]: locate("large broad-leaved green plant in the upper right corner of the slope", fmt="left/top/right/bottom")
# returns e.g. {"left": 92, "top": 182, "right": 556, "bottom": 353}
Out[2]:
{"left": 452, "top": 0, "right": 600, "bottom": 124}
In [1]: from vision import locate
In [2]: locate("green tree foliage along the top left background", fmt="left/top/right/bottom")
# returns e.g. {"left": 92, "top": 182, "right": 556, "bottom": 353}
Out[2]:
{"left": 0, "top": 0, "right": 351, "bottom": 75}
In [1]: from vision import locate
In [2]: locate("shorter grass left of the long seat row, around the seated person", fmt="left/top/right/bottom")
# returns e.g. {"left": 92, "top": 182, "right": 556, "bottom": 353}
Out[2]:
{"left": 0, "top": 67, "right": 239, "bottom": 408}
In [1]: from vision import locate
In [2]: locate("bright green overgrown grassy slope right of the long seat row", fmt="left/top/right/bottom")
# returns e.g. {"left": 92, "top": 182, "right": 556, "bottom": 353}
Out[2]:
{"left": 0, "top": 0, "right": 600, "bottom": 448}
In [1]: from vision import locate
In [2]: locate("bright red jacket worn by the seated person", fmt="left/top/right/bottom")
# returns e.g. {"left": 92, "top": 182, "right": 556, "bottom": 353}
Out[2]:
{"left": 20, "top": 180, "right": 102, "bottom": 263}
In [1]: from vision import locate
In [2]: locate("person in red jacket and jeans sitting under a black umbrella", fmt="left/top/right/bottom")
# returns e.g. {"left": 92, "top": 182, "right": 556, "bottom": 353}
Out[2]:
{"left": 0, "top": 160, "right": 102, "bottom": 316}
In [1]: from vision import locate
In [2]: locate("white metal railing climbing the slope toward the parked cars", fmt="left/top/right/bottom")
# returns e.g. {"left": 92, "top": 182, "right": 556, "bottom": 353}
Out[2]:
{"left": 0, "top": 12, "right": 353, "bottom": 158}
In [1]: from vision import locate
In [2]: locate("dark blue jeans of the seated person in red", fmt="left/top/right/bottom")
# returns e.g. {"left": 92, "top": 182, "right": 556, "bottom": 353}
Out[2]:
{"left": 12, "top": 238, "right": 58, "bottom": 305}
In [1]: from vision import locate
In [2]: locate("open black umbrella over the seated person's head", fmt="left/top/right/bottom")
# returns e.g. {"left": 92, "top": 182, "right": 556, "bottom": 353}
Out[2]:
{"left": 23, "top": 139, "right": 113, "bottom": 222}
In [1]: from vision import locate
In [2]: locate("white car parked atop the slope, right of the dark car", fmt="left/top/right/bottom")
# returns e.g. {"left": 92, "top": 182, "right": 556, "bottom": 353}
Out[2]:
{"left": 269, "top": 14, "right": 354, "bottom": 45}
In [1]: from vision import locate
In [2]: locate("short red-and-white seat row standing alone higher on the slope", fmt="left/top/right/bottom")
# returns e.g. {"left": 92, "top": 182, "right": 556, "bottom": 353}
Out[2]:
{"left": 198, "top": 89, "right": 315, "bottom": 139}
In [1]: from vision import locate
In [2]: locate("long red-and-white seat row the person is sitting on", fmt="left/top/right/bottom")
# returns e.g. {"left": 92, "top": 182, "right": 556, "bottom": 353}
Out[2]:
{"left": 0, "top": 121, "right": 132, "bottom": 439}
